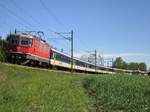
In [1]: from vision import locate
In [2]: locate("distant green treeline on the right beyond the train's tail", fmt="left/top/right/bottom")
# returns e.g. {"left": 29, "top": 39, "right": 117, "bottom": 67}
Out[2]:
{"left": 112, "top": 57, "right": 147, "bottom": 71}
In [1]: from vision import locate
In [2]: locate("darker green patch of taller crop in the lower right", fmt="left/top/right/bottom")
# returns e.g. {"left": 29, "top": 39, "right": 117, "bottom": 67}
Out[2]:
{"left": 84, "top": 75, "right": 150, "bottom": 112}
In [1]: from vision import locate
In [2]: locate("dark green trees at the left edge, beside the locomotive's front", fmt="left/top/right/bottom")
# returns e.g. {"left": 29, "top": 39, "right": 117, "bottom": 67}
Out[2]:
{"left": 0, "top": 38, "right": 7, "bottom": 62}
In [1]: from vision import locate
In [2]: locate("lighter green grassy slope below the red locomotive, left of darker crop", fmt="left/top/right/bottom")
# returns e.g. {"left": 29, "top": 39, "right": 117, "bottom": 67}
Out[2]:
{"left": 0, "top": 64, "right": 87, "bottom": 112}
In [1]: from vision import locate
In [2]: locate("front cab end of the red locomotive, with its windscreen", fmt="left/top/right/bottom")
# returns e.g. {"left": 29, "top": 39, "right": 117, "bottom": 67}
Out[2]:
{"left": 7, "top": 33, "right": 33, "bottom": 64}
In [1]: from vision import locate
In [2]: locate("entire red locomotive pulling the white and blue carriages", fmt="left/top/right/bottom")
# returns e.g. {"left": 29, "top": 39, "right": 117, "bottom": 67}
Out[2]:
{"left": 7, "top": 32, "right": 50, "bottom": 66}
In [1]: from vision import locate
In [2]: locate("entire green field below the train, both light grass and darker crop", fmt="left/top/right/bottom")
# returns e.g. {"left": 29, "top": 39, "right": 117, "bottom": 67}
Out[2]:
{"left": 0, "top": 64, "right": 150, "bottom": 112}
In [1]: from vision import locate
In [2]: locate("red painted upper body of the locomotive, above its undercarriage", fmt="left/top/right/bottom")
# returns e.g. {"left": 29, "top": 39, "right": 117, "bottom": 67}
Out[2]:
{"left": 8, "top": 34, "right": 50, "bottom": 63}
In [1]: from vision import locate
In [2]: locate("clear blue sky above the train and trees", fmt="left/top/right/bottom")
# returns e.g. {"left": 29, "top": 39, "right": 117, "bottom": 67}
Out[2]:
{"left": 0, "top": 0, "right": 150, "bottom": 66}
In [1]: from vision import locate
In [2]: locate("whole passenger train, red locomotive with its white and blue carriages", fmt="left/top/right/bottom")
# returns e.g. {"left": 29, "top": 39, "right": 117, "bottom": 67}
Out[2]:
{"left": 7, "top": 32, "right": 147, "bottom": 74}
